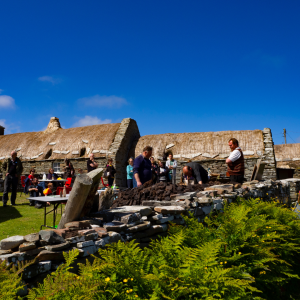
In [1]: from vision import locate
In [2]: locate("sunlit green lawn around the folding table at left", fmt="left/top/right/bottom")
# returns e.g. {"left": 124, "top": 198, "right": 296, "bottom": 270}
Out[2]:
{"left": 0, "top": 192, "right": 65, "bottom": 240}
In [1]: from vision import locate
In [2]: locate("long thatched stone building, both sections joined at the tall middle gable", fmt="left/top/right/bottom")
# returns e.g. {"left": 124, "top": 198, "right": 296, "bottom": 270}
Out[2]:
{"left": 0, "top": 117, "right": 276, "bottom": 186}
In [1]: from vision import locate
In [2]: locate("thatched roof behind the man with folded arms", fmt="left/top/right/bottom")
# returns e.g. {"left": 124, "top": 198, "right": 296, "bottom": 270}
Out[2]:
{"left": 135, "top": 130, "right": 265, "bottom": 160}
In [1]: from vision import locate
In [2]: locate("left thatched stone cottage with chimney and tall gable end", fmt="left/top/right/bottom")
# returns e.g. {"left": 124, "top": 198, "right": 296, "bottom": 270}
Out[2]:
{"left": 0, "top": 117, "right": 140, "bottom": 186}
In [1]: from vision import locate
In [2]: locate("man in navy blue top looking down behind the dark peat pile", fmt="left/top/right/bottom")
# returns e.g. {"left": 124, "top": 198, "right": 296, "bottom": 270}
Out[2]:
{"left": 133, "top": 146, "right": 153, "bottom": 187}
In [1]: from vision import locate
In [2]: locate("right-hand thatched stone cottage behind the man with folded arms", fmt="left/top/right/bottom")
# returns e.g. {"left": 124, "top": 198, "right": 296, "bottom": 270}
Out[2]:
{"left": 130, "top": 128, "right": 276, "bottom": 180}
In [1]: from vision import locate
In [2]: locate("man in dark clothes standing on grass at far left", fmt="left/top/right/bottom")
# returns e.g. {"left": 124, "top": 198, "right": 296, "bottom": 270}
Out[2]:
{"left": 2, "top": 151, "right": 23, "bottom": 207}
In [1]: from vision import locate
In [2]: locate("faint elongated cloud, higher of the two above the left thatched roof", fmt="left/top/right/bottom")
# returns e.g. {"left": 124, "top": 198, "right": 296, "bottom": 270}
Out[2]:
{"left": 78, "top": 95, "right": 128, "bottom": 108}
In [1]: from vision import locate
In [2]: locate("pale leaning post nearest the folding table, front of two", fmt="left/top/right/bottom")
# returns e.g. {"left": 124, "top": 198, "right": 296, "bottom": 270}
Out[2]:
{"left": 58, "top": 174, "right": 93, "bottom": 229}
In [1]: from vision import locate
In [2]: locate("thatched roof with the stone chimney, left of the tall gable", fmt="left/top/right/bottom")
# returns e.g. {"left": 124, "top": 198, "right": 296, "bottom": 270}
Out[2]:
{"left": 0, "top": 118, "right": 120, "bottom": 160}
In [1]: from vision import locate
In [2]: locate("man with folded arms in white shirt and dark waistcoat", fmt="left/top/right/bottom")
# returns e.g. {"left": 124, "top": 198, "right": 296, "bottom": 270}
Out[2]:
{"left": 226, "top": 138, "right": 245, "bottom": 183}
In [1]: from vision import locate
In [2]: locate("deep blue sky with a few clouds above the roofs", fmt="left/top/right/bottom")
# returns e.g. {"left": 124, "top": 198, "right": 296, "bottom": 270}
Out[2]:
{"left": 0, "top": 0, "right": 300, "bottom": 144}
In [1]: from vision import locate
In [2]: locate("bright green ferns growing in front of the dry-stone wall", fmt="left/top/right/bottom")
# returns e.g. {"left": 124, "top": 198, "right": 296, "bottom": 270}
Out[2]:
{"left": 3, "top": 199, "right": 300, "bottom": 300}
